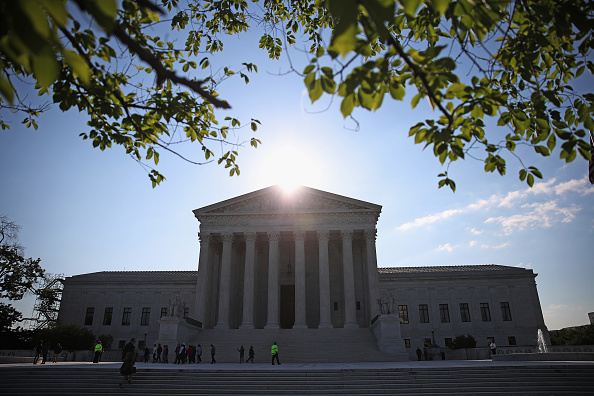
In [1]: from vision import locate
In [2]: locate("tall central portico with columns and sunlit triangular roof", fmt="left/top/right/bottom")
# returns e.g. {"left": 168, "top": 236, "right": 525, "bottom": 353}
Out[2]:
{"left": 194, "top": 186, "right": 381, "bottom": 329}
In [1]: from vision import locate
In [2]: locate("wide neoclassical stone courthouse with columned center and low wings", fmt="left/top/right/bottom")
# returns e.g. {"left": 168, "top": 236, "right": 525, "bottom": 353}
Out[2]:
{"left": 59, "top": 186, "right": 547, "bottom": 362}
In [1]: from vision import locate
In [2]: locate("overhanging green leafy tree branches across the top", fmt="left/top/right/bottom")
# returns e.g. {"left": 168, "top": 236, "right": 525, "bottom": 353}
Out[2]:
{"left": 0, "top": 0, "right": 594, "bottom": 190}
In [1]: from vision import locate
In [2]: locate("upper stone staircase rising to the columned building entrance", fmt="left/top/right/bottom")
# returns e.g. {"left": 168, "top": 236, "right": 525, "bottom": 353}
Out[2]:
{"left": 192, "top": 329, "right": 400, "bottom": 363}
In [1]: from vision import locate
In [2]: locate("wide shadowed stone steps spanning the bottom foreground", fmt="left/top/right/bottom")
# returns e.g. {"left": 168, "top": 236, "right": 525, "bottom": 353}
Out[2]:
{"left": 0, "top": 362, "right": 594, "bottom": 395}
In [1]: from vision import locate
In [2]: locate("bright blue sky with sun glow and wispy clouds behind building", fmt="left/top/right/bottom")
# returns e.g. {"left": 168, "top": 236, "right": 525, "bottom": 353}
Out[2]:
{"left": 0, "top": 12, "right": 594, "bottom": 329}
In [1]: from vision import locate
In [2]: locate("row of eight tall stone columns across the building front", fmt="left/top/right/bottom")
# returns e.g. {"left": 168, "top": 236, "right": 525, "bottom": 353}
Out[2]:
{"left": 196, "top": 229, "right": 378, "bottom": 329}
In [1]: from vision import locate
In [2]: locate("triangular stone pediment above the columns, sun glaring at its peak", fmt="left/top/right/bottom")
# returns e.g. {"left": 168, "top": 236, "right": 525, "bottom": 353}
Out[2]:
{"left": 194, "top": 186, "right": 381, "bottom": 217}
